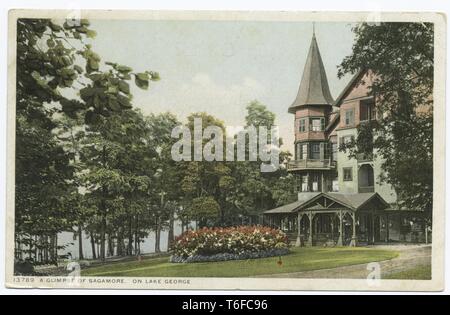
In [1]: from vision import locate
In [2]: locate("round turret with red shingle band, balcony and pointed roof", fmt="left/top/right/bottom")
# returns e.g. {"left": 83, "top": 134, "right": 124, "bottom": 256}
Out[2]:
{"left": 288, "top": 34, "right": 334, "bottom": 191}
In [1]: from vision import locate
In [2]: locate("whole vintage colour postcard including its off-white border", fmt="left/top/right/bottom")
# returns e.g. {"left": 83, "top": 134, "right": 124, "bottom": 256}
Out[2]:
{"left": 6, "top": 10, "right": 446, "bottom": 291}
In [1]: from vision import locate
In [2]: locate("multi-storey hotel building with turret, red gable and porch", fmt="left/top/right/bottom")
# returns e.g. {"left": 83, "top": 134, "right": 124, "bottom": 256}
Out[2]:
{"left": 264, "top": 34, "right": 431, "bottom": 246}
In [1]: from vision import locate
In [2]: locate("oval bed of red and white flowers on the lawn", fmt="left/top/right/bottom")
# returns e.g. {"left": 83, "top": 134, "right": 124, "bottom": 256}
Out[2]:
{"left": 170, "top": 226, "right": 289, "bottom": 262}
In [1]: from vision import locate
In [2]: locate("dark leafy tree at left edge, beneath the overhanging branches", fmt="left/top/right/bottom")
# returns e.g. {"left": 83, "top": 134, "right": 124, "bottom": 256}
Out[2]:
{"left": 15, "top": 116, "right": 72, "bottom": 262}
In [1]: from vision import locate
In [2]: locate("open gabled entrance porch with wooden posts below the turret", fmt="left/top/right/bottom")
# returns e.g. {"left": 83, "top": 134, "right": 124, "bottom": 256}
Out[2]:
{"left": 264, "top": 193, "right": 400, "bottom": 246}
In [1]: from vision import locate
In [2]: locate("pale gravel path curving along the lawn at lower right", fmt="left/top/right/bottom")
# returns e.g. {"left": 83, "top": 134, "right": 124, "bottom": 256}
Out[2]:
{"left": 258, "top": 245, "right": 431, "bottom": 279}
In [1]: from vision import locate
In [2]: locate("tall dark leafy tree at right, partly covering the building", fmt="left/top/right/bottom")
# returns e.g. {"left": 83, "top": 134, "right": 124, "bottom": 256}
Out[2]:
{"left": 338, "top": 23, "right": 434, "bottom": 211}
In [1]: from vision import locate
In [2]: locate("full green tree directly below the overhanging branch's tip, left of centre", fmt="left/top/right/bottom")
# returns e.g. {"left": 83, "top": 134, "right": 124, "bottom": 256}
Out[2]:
{"left": 81, "top": 110, "right": 151, "bottom": 259}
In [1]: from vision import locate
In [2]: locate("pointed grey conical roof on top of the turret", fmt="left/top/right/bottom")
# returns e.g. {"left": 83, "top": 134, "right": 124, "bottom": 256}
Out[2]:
{"left": 288, "top": 35, "right": 333, "bottom": 113}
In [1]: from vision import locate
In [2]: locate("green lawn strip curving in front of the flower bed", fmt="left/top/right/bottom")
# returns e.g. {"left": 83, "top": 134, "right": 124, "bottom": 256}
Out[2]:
{"left": 82, "top": 247, "right": 398, "bottom": 277}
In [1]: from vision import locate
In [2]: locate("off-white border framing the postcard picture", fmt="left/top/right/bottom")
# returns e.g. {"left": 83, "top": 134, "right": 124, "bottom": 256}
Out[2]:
{"left": 5, "top": 10, "right": 447, "bottom": 291}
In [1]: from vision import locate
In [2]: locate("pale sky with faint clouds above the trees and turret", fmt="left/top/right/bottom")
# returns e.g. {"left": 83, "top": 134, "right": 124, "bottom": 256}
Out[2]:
{"left": 91, "top": 20, "right": 354, "bottom": 152}
